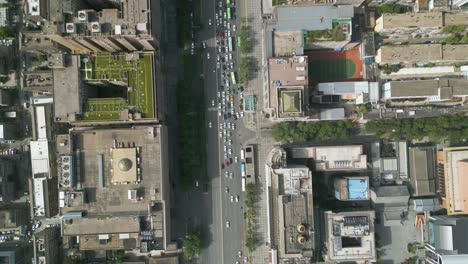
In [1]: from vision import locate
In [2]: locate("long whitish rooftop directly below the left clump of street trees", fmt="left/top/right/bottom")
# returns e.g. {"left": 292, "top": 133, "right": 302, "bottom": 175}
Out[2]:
{"left": 290, "top": 145, "right": 367, "bottom": 171}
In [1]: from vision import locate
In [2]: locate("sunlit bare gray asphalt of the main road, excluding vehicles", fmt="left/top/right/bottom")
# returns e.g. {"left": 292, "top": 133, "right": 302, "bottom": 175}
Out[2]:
{"left": 199, "top": 0, "right": 249, "bottom": 264}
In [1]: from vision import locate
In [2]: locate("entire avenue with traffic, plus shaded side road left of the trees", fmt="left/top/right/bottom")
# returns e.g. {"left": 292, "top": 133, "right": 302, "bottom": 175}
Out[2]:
{"left": 162, "top": 0, "right": 255, "bottom": 264}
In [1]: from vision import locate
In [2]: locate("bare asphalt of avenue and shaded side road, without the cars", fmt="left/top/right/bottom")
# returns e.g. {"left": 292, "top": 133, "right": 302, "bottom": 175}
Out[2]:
{"left": 157, "top": 0, "right": 252, "bottom": 264}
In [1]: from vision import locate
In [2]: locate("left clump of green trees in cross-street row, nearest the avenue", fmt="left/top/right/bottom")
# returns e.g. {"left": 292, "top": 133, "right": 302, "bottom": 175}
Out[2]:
{"left": 273, "top": 120, "right": 354, "bottom": 143}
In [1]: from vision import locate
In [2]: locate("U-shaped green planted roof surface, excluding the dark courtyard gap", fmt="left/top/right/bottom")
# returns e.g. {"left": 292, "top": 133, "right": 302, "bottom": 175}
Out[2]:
{"left": 82, "top": 54, "right": 154, "bottom": 120}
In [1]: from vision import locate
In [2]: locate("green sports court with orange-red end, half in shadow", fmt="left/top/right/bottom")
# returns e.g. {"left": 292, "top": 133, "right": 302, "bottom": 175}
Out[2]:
{"left": 307, "top": 48, "right": 363, "bottom": 82}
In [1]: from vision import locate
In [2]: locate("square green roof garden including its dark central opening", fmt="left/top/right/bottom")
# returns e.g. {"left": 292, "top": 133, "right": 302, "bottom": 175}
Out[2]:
{"left": 80, "top": 53, "right": 155, "bottom": 121}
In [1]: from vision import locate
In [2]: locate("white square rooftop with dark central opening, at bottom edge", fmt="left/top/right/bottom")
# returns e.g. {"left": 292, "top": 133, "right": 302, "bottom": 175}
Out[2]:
{"left": 324, "top": 211, "right": 376, "bottom": 262}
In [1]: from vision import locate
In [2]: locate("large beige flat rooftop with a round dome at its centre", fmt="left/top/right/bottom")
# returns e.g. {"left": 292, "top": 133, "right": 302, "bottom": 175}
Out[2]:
{"left": 66, "top": 126, "right": 166, "bottom": 216}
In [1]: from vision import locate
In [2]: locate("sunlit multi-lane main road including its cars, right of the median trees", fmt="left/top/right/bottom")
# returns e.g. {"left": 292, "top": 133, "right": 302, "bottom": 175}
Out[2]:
{"left": 198, "top": 0, "right": 248, "bottom": 264}
